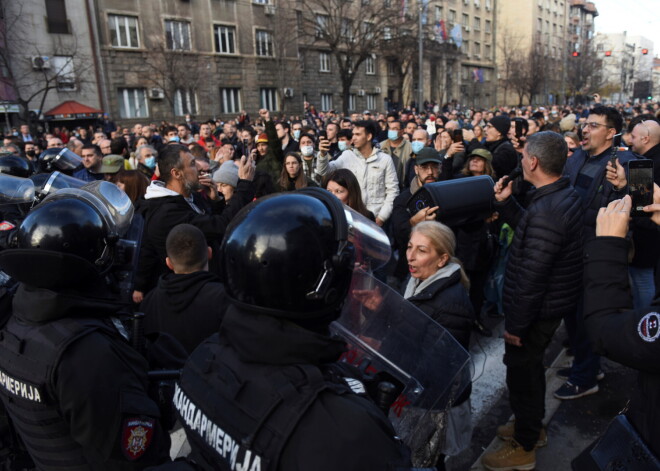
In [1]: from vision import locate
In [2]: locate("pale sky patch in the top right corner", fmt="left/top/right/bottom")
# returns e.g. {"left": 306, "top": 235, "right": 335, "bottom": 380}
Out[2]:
{"left": 593, "top": 0, "right": 660, "bottom": 57}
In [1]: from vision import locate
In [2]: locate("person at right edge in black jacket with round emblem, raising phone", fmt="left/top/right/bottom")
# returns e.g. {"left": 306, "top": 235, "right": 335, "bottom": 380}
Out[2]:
{"left": 574, "top": 195, "right": 660, "bottom": 469}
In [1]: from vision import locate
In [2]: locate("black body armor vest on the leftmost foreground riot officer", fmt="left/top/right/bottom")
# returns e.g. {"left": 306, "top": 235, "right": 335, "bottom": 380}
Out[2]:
{"left": 0, "top": 317, "right": 119, "bottom": 471}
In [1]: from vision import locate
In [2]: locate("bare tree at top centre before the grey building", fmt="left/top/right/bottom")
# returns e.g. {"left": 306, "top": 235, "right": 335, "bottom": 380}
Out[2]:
{"left": 301, "top": 0, "right": 399, "bottom": 113}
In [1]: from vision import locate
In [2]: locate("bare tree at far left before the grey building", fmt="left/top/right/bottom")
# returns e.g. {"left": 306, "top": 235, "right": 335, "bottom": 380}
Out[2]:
{"left": 0, "top": 2, "right": 93, "bottom": 133}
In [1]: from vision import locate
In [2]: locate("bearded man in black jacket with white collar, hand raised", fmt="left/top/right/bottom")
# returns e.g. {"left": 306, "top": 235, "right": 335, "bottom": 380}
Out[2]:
{"left": 133, "top": 144, "right": 254, "bottom": 303}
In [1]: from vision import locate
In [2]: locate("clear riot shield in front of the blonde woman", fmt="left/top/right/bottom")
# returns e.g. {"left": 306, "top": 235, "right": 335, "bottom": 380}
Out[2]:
{"left": 331, "top": 268, "right": 471, "bottom": 449}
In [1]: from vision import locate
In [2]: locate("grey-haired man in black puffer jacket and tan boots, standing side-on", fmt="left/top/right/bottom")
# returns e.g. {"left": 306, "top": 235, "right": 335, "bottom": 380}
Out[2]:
{"left": 482, "top": 131, "right": 583, "bottom": 471}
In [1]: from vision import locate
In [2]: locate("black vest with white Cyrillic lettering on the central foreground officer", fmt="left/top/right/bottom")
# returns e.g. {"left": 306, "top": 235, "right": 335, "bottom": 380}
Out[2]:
{"left": 174, "top": 334, "right": 353, "bottom": 471}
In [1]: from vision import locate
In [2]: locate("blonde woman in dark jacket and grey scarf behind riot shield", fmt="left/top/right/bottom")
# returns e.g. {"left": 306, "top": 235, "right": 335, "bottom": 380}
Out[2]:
{"left": 404, "top": 221, "right": 475, "bottom": 470}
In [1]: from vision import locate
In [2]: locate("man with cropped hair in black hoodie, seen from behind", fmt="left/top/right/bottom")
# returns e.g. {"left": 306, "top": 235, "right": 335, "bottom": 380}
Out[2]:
{"left": 140, "top": 224, "right": 227, "bottom": 354}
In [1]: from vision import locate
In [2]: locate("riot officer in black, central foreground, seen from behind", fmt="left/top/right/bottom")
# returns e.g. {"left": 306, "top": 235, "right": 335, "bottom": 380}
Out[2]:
{"left": 174, "top": 188, "right": 410, "bottom": 471}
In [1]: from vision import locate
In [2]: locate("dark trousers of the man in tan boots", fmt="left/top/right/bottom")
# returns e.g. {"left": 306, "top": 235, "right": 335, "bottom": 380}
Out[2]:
{"left": 504, "top": 319, "right": 561, "bottom": 451}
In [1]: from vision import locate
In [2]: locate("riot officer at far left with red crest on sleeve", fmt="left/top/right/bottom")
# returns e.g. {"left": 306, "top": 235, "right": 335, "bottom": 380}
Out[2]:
{"left": 0, "top": 182, "right": 169, "bottom": 471}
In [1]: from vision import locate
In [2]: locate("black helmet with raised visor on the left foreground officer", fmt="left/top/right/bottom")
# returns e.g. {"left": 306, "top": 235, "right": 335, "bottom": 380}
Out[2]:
{"left": 0, "top": 181, "right": 133, "bottom": 289}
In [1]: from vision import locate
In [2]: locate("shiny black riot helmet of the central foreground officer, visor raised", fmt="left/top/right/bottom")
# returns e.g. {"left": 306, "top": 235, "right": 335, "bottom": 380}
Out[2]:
{"left": 221, "top": 188, "right": 390, "bottom": 320}
